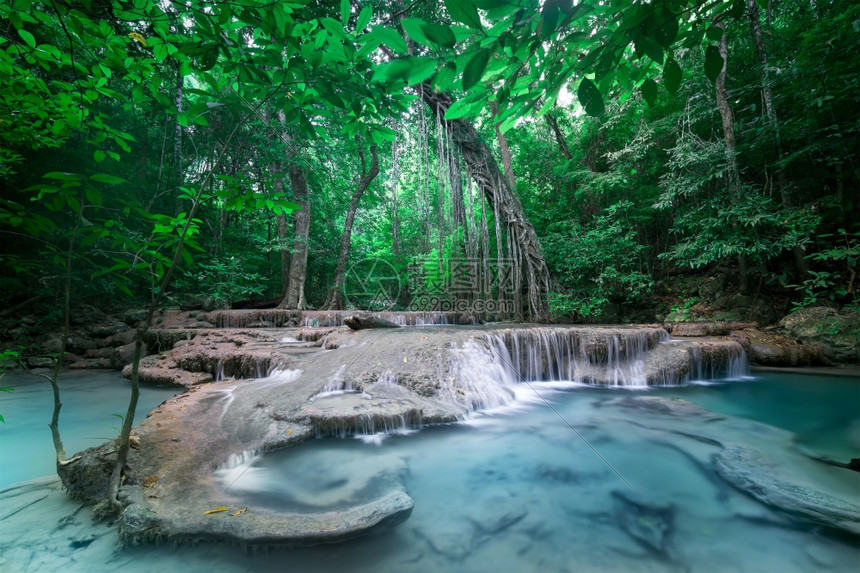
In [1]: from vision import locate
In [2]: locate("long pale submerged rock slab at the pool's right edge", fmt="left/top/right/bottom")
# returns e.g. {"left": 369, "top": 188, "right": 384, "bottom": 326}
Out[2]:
{"left": 713, "top": 445, "right": 860, "bottom": 535}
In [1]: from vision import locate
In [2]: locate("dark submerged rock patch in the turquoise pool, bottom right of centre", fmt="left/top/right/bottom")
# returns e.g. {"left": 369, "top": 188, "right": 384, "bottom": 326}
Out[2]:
{"left": 612, "top": 490, "right": 676, "bottom": 558}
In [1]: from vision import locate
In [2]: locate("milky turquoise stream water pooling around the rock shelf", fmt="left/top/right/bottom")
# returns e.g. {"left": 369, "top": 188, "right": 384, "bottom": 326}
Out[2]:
{"left": 0, "top": 366, "right": 860, "bottom": 573}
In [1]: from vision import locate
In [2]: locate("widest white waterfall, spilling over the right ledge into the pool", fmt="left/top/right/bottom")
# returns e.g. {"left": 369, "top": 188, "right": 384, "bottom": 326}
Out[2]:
{"left": 454, "top": 327, "right": 749, "bottom": 394}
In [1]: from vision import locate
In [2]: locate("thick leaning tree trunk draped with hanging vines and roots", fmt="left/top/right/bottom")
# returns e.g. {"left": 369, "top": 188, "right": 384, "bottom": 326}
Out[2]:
{"left": 420, "top": 84, "right": 549, "bottom": 320}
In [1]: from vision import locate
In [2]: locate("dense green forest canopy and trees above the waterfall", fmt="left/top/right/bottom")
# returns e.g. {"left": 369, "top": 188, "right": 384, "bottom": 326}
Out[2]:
{"left": 0, "top": 0, "right": 860, "bottom": 321}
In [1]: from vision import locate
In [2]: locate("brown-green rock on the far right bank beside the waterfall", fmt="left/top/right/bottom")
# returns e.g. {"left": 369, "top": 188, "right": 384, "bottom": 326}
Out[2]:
{"left": 779, "top": 307, "right": 860, "bottom": 364}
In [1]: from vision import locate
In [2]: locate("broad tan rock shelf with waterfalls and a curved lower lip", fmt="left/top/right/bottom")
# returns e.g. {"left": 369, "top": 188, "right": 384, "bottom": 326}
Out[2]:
{"left": 61, "top": 326, "right": 746, "bottom": 545}
